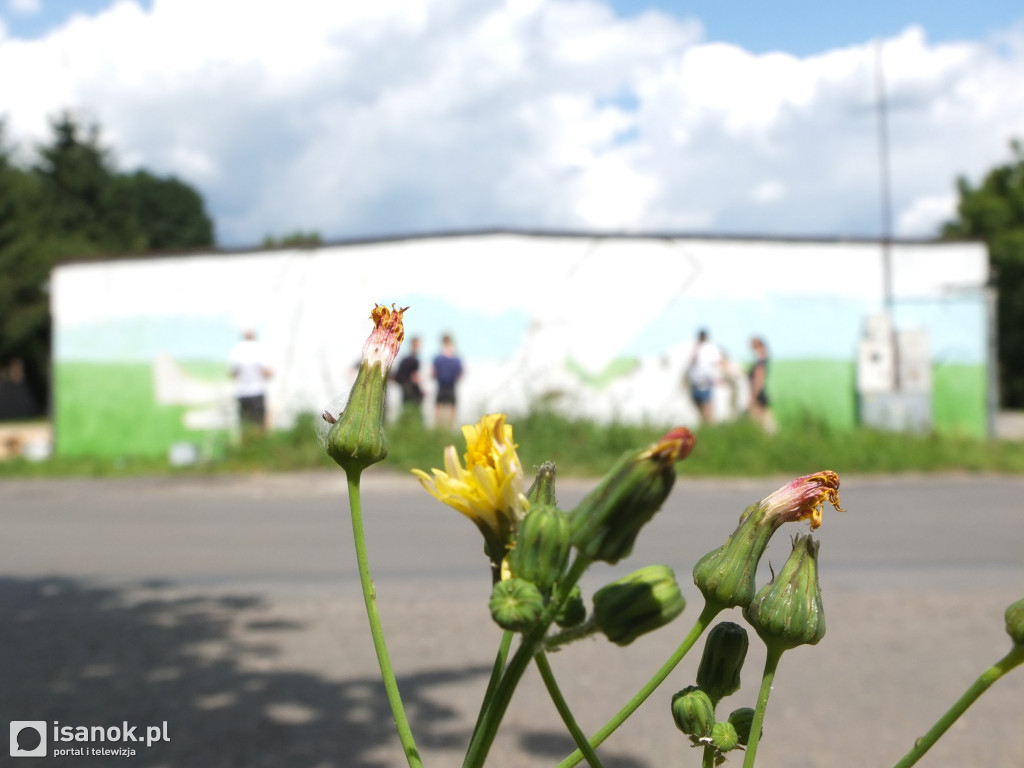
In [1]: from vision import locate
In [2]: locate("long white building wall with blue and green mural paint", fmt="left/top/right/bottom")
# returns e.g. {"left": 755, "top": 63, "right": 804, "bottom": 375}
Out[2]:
{"left": 52, "top": 233, "right": 988, "bottom": 455}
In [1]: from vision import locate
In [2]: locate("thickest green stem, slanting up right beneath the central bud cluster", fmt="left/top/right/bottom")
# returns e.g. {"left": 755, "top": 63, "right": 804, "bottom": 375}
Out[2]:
{"left": 462, "top": 555, "right": 591, "bottom": 768}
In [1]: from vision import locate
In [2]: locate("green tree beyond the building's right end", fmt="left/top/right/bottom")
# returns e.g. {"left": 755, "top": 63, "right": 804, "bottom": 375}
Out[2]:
{"left": 942, "top": 140, "right": 1024, "bottom": 409}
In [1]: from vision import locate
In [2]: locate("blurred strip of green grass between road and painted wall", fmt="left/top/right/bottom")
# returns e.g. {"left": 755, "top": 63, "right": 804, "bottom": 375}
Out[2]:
{"left": 6, "top": 412, "right": 1024, "bottom": 477}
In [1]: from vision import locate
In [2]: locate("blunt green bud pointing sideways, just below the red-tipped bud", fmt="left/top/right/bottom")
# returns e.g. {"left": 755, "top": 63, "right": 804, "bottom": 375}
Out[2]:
{"left": 594, "top": 565, "right": 686, "bottom": 645}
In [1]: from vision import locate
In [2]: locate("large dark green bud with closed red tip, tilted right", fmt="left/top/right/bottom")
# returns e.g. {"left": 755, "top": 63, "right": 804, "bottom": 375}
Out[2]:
{"left": 570, "top": 434, "right": 694, "bottom": 563}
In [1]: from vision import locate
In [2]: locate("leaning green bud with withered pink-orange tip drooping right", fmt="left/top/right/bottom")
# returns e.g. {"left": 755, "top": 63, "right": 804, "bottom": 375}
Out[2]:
{"left": 693, "top": 470, "right": 844, "bottom": 608}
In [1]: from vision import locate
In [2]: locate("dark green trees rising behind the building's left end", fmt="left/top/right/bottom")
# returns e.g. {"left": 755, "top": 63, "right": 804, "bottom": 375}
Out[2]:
{"left": 0, "top": 113, "right": 213, "bottom": 415}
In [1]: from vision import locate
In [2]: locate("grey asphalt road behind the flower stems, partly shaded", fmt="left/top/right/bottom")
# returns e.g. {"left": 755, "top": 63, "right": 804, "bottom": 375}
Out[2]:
{"left": 0, "top": 472, "right": 1024, "bottom": 768}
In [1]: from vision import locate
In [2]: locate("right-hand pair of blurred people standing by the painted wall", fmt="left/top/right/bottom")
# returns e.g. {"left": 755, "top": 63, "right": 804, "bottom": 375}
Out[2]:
{"left": 686, "top": 329, "right": 775, "bottom": 432}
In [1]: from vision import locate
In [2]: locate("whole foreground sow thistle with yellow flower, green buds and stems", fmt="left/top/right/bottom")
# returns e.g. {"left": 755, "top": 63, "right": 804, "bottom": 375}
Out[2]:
{"left": 317, "top": 305, "right": 1024, "bottom": 768}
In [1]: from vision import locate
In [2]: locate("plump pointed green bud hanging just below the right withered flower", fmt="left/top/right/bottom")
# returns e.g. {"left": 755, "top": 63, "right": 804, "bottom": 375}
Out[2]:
{"left": 743, "top": 534, "right": 825, "bottom": 650}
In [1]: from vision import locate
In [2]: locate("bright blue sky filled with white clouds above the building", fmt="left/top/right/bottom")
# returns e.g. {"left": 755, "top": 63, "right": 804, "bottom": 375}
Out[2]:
{"left": 0, "top": 0, "right": 1024, "bottom": 247}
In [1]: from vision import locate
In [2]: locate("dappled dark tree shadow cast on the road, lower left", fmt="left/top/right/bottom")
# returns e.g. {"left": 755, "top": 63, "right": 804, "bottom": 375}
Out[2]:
{"left": 0, "top": 578, "right": 643, "bottom": 768}
